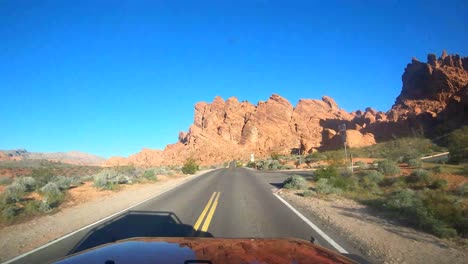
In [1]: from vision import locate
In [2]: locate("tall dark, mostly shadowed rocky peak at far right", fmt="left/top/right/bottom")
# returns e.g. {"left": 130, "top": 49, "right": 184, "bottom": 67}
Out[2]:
{"left": 363, "top": 51, "right": 468, "bottom": 140}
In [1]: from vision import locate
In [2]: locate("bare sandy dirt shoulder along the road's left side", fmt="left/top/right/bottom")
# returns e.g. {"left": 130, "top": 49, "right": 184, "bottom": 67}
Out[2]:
{"left": 0, "top": 170, "right": 208, "bottom": 262}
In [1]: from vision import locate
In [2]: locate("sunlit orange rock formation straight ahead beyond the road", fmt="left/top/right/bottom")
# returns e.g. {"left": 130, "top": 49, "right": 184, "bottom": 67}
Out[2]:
{"left": 106, "top": 94, "right": 375, "bottom": 166}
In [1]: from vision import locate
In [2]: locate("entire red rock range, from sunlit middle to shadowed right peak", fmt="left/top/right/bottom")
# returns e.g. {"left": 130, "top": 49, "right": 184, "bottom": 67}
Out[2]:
{"left": 106, "top": 51, "right": 468, "bottom": 166}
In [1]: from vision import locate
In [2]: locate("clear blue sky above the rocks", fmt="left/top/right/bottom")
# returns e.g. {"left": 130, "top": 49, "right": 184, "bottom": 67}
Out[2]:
{"left": 0, "top": 0, "right": 468, "bottom": 157}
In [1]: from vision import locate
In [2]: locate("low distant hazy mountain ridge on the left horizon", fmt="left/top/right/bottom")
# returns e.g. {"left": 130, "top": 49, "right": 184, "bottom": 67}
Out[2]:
{"left": 0, "top": 149, "right": 106, "bottom": 166}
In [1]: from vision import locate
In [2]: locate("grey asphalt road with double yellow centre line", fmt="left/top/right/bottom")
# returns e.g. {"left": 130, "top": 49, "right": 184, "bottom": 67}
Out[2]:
{"left": 5, "top": 167, "right": 365, "bottom": 263}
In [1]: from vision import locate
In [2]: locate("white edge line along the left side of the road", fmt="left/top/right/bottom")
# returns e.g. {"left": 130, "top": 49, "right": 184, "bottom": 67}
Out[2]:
{"left": 2, "top": 170, "right": 214, "bottom": 264}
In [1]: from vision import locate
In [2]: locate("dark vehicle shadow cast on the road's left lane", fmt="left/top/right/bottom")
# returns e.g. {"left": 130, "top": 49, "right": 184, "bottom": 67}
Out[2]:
{"left": 68, "top": 211, "right": 213, "bottom": 255}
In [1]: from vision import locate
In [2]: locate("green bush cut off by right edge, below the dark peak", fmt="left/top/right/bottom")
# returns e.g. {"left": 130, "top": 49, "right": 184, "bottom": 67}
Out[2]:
{"left": 448, "top": 126, "right": 468, "bottom": 163}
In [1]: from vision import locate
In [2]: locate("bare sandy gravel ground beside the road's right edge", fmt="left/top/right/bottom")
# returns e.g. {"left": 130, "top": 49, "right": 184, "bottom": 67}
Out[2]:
{"left": 280, "top": 190, "right": 468, "bottom": 264}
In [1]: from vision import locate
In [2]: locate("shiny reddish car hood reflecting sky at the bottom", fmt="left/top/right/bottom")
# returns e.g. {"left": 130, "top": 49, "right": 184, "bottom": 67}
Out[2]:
{"left": 56, "top": 238, "right": 355, "bottom": 264}
